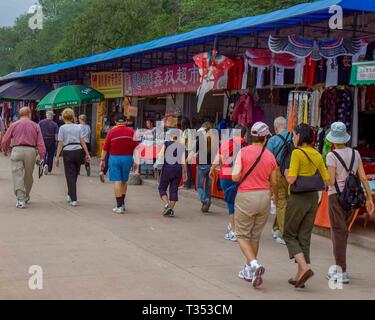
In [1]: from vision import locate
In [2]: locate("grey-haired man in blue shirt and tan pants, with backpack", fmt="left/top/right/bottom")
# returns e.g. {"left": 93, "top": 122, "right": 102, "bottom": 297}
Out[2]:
{"left": 267, "top": 117, "right": 292, "bottom": 245}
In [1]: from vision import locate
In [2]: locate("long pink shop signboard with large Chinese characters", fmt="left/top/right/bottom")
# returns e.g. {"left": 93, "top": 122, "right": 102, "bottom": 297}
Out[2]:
{"left": 124, "top": 63, "right": 227, "bottom": 97}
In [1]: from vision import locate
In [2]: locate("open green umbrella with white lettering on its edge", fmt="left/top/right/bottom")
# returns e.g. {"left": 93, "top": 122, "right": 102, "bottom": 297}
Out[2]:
{"left": 37, "top": 85, "right": 104, "bottom": 110}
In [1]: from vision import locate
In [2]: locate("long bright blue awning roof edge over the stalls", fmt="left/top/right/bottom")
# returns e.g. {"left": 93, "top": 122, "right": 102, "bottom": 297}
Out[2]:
{"left": 0, "top": 0, "right": 375, "bottom": 81}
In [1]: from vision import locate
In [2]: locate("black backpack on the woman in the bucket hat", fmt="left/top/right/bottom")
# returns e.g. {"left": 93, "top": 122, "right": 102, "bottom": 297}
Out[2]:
{"left": 333, "top": 149, "right": 366, "bottom": 212}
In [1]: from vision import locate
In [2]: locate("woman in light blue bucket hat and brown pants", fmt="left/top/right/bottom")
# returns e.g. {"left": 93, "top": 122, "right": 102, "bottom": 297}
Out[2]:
{"left": 326, "top": 122, "right": 374, "bottom": 284}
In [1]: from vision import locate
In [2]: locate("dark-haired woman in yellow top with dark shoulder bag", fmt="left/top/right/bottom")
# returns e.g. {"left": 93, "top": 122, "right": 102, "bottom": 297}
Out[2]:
{"left": 284, "top": 124, "right": 329, "bottom": 288}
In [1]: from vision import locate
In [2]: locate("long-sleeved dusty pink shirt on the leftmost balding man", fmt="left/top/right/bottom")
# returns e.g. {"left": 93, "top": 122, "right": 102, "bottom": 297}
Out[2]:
{"left": 1, "top": 119, "right": 46, "bottom": 159}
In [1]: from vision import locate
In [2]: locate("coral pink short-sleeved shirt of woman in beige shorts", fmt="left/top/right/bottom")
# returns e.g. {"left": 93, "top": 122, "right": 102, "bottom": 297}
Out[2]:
{"left": 236, "top": 145, "right": 277, "bottom": 192}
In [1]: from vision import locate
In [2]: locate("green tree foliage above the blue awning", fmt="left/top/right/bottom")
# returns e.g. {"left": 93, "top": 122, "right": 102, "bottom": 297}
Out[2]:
{"left": 0, "top": 0, "right": 306, "bottom": 75}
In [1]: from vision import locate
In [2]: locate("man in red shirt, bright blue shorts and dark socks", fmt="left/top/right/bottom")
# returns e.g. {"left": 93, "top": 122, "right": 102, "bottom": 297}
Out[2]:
{"left": 100, "top": 114, "right": 138, "bottom": 214}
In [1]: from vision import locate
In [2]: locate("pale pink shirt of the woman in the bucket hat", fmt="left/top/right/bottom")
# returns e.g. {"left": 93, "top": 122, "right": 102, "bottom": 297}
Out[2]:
{"left": 326, "top": 148, "right": 362, "bottom": 195}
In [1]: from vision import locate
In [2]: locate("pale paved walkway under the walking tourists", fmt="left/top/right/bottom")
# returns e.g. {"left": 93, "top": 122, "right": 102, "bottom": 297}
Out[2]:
{"left": 0, "top": 156, "right": 375, "bottom": 299}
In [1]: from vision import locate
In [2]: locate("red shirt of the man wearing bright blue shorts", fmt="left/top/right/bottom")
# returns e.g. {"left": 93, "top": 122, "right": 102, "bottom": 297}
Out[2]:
{"left": 103, "top": 125, "right": 138, "bottom": 156}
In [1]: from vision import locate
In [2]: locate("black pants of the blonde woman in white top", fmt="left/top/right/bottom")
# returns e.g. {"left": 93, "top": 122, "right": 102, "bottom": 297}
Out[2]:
{"left": 63, "top": 149, "right": 83, "bottom": 201}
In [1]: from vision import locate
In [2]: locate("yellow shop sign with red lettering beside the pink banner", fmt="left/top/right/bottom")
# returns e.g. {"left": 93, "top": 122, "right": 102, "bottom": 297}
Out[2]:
{"left": 91, "top": 72, "right": 124, "bottom": 99}
